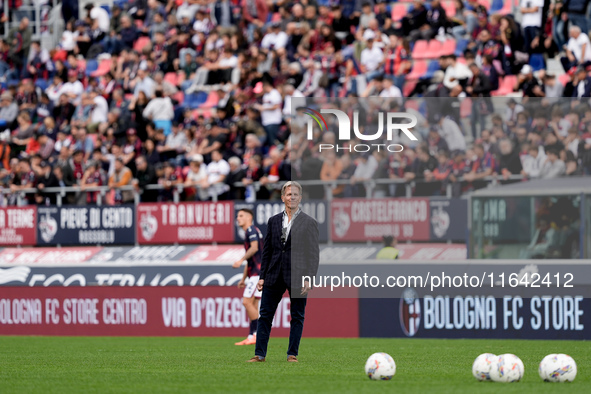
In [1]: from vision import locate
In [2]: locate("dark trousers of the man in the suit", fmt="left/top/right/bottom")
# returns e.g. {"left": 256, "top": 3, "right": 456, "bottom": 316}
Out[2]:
{"left": 254, "top": 279, "right": 307, "bottom": 357}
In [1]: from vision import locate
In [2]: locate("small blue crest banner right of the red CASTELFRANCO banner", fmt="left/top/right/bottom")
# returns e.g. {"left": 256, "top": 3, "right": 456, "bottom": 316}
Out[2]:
{"left": 429, "top": 198, "right": 468, "bottom": 242}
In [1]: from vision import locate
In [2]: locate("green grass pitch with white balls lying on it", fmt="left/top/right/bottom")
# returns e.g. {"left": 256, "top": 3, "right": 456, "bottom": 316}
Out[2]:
{"left": 0, "top": 337, "right": 591, "bottom": 394}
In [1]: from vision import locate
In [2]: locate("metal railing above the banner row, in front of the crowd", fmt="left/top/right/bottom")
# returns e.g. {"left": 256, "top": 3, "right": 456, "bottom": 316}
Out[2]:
{"left": 0, "top": 175, "right": 525, "bottom": 206}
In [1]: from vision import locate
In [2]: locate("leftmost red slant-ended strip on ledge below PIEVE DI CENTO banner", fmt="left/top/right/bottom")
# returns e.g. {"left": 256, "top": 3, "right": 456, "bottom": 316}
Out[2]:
{"left": 0, "top": 247, "right": 103, "bottom": 264}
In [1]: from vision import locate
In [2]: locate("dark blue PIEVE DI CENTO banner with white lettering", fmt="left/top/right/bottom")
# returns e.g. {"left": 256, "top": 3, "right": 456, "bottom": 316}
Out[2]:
{"left": 37, "top": 204, "right": 135, "bottom": 246}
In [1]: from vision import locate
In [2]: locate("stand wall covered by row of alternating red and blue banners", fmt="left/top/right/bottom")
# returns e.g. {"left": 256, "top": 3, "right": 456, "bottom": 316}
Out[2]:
{"left": 0, "top": 198, "right": 468, "bottom": 246}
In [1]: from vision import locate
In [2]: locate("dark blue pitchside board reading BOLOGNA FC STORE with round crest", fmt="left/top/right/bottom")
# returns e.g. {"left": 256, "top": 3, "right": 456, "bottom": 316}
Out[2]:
{"left": 359, "top": 294, "right": 591, "bottom": 339}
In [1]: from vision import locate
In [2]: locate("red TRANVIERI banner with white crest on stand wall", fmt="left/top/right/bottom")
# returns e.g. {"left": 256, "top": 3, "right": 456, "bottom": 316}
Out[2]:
{"left": 137, "top": 201, "right": 235, "bottom": 244}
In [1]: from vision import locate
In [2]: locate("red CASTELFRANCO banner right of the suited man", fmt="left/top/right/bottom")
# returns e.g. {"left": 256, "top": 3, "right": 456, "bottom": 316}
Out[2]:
{"left": 331, "top": 198, "right": 429, "bottom": 242}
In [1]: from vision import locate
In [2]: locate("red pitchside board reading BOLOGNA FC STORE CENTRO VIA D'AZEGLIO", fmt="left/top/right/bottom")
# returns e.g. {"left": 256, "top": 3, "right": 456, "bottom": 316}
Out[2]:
{"left": 0, "top": 287, "right": 359, "bottom": 338}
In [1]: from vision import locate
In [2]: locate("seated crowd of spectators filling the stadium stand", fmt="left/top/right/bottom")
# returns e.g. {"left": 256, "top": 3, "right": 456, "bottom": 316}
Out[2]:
{"left": 0, "top": 0, "right": 591, "bottom": 204}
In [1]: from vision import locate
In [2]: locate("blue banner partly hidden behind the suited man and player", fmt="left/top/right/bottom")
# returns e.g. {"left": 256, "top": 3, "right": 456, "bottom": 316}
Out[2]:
{"left": 234, "top": 200, "right": 329, "bottom": 243}
